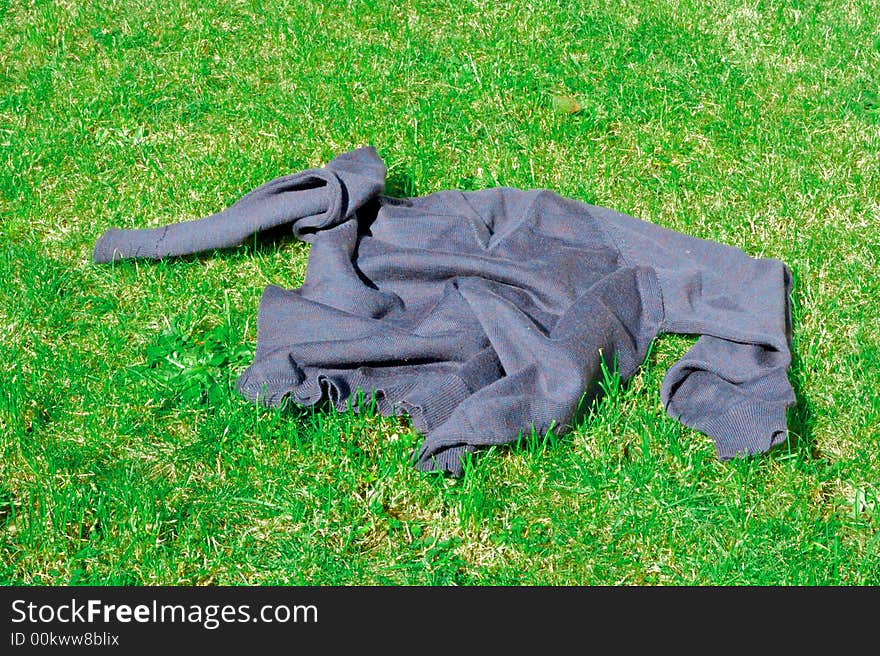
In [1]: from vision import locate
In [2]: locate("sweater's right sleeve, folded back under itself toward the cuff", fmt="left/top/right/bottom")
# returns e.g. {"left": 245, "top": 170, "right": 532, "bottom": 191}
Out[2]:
{"left": 591, "top": 207, "right": 795, "bottom": 460}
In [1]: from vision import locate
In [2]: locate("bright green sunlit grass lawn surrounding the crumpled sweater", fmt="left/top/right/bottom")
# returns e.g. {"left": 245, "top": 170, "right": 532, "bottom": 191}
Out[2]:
{"left": 0, "top": 0, "right": 880, "bottom": 585}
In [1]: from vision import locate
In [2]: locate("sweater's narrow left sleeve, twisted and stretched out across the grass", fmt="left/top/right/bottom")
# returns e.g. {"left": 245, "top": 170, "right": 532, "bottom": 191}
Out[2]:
{"left": 92, "top": 147, "right": 385, "bottom": 264}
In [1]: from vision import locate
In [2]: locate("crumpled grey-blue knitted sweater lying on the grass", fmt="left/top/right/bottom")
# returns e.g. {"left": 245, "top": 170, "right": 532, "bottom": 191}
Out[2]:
{"left": 93, "top": 147, "right": 795, "bottom": 476}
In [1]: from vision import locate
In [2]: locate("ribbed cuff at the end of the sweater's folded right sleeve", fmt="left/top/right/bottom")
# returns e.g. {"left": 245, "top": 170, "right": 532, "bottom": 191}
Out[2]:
{"left": 695, "top": 401, "right": 788, "bottom": 460}
